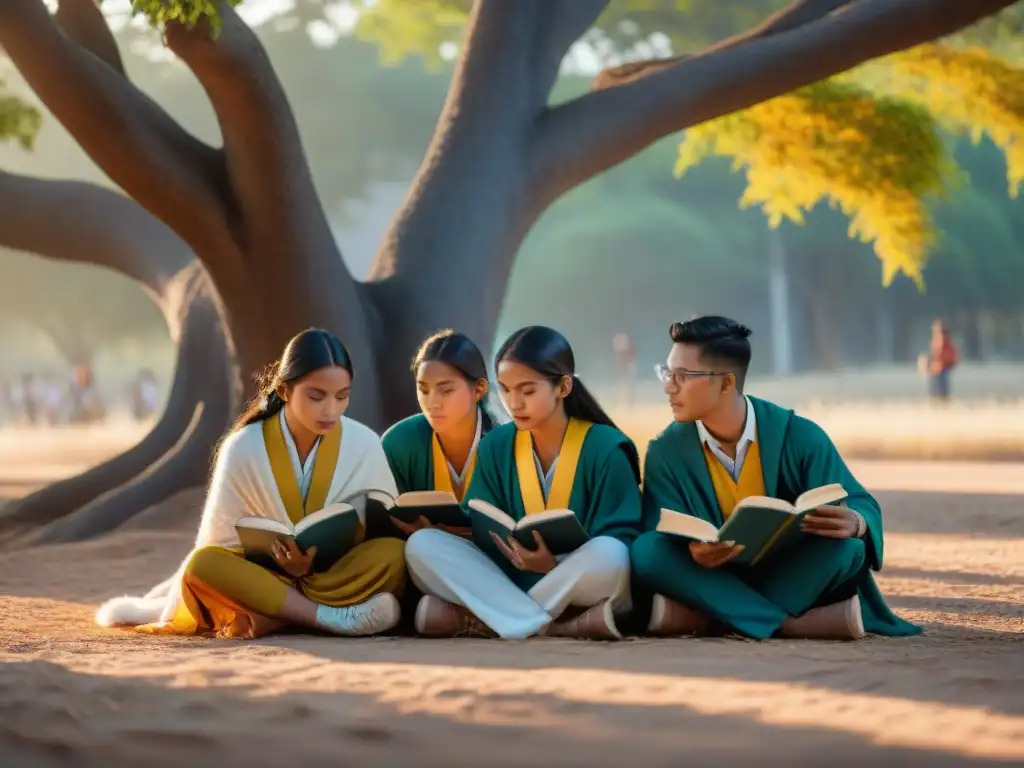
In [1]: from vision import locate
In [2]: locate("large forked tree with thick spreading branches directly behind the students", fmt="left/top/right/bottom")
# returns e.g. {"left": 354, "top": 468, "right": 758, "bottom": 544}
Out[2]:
{"left": 0, "top": 0, "right": 1011, "bottom": 540}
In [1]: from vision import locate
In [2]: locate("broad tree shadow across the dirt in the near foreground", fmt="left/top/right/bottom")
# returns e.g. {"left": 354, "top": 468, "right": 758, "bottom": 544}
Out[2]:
{"left": 0, "top": 660, "right": 1011, "bottom": 768}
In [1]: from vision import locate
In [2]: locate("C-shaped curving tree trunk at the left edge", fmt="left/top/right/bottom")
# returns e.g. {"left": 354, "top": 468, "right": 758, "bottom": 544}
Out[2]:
{"left": 0, "top": 172, "right": 236, "bottom": 541}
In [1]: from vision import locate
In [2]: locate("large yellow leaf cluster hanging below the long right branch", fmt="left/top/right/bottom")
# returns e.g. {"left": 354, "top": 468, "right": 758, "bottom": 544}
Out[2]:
{"left": 676, "top": 80, "right": 955, "bottom": 285}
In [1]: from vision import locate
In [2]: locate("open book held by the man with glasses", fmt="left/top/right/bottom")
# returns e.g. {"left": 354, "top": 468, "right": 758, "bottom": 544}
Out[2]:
{"left": 656, "top": 482, "right": 847, "bottom": 565}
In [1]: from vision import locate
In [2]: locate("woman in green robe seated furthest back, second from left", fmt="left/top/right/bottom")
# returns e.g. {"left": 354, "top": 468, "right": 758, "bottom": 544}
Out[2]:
{"left": 382, "top": 330, "right": 494, "bottom": 536}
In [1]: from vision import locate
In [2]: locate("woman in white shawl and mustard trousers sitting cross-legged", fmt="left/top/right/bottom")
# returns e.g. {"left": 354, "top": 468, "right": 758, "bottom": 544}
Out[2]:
{"left": 96, "top": 329, "right": 406, "bottom": 637}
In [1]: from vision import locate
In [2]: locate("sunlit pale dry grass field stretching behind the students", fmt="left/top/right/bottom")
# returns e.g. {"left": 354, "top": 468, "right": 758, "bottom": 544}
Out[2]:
{"left": 0, "top": 365, "right": 1024, "bottom": 473}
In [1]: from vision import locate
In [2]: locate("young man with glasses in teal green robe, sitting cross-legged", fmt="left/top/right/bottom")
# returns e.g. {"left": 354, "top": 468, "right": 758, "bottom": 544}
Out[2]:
{"left": 632, "top": 316, "right": 921, "bottom": 640}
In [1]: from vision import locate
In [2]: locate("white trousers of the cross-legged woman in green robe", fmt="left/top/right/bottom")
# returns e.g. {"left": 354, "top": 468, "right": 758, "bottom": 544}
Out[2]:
{"left": 406, "top": 528, "right": 632, "bottom": 639}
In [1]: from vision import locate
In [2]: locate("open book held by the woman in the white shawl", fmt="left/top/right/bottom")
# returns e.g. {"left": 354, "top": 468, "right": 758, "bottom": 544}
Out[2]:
{"left": 234, "top": 502, "right": 362, "bottom": 573}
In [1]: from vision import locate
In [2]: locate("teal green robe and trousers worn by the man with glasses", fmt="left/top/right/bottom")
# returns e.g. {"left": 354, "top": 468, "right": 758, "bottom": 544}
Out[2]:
{"left": 632, "top": 397, "right": 921, "bottom": 638}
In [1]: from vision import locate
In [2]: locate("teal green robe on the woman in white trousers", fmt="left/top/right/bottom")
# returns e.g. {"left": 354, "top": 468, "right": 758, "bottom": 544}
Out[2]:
{"left": 464, "top": 423, "right": 643, "bottom": 590}
